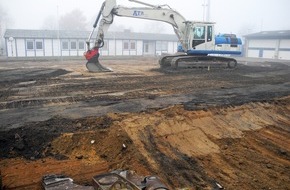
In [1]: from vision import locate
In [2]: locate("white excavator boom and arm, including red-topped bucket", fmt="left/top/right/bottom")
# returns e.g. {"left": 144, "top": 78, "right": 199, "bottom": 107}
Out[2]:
{"left": 85, "top": 0, "right": 190, "bottom": 72}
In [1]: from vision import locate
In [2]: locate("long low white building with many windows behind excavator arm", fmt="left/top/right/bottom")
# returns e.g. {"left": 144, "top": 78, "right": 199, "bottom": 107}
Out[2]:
{"left": 4, "top": 29, "right": 178, "bottom": 57}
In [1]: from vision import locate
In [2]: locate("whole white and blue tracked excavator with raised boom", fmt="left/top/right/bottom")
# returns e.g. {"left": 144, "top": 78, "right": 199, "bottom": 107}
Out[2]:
{"left": 84, "top": 0, "right": 242, "bottom": 72}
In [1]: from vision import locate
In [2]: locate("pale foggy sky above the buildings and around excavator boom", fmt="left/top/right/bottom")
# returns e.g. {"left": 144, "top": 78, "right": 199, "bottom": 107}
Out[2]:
{"left": 0, "top": 0, "right": 290, "bottom": 34}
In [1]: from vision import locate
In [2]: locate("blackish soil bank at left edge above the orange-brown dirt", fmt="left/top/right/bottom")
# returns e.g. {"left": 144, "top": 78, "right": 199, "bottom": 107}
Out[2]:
{"left": 0, "top": 116, "right": 112, "bottom": 160}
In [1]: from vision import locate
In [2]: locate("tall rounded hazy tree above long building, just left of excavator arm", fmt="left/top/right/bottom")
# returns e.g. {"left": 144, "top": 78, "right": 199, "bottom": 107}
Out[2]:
{"left": 59, "top": 9, "right": 87, "bottom": 30}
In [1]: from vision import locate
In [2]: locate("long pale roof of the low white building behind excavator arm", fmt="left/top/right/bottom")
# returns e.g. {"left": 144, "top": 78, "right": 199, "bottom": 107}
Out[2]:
{"left": 4, "top": 29, "right": 178, "bottom": 41}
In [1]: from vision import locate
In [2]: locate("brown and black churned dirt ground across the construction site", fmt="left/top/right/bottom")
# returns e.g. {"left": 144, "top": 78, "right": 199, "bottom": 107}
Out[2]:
{"left": 0, "top": 58, "right": 290, "bottom": 190}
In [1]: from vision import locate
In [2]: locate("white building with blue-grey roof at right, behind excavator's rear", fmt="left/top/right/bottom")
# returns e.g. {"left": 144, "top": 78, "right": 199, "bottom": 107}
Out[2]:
{"left": 244, "top": 30, "right": 290, "bottom": 60}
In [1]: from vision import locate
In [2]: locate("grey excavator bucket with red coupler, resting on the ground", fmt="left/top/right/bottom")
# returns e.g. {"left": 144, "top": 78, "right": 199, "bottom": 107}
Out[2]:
{"left": 84, "top": 48, "right": 112, "bottom": 73}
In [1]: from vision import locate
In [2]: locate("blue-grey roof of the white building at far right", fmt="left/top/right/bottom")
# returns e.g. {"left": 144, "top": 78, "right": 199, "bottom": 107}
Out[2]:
{"left": 244, "top": 30, "right": 290, "bottom": 39}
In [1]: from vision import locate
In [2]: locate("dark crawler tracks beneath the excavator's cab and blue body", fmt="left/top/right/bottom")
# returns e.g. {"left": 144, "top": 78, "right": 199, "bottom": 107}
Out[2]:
{"left": 159, "top": 55, "right": 237, "bottom": 69}
